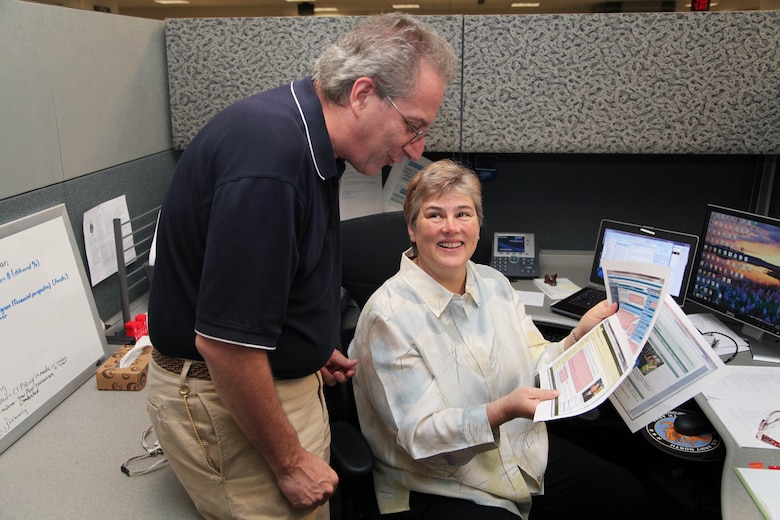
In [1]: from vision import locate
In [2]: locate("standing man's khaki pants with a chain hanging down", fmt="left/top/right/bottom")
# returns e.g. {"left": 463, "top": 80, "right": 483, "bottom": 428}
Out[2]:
{"left": 147, "top": 361, "right": 330, "bottom": 520}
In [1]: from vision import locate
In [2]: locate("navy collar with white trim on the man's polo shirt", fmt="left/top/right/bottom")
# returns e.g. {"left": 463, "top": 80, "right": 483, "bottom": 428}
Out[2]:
{"left": 290, "top": 76, "right": 345, "bottom": 180}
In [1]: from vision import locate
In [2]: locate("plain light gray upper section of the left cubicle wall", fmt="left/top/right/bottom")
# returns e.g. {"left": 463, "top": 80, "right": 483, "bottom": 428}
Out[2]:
{"left": 0, "top": 0, "right": 171, "bottom": 199}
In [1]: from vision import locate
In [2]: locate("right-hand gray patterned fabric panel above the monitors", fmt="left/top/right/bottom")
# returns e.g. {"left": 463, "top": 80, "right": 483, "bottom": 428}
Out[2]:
{"left": 462, "top": 11, "right": 780, "bottom": 154}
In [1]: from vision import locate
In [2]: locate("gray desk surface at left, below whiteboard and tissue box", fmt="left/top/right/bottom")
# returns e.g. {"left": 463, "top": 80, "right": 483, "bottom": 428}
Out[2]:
{"left": 0, "top": 378, "right": 201, "bottom": 520}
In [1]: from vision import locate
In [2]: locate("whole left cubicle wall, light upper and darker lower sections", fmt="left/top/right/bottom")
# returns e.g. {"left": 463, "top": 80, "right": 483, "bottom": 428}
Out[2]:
{"left": 0, "top": 0, "right": 178, "bottom": 319}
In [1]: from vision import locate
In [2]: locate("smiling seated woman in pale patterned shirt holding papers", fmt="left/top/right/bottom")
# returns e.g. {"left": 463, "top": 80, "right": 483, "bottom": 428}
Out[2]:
{"left": 349, "top": 161, "right": 644, "bottom": 520}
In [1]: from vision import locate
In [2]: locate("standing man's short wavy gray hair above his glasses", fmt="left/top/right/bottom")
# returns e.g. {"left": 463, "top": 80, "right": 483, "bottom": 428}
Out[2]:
{"left": 312, "top": 13, "right": 458, "bottom": 105}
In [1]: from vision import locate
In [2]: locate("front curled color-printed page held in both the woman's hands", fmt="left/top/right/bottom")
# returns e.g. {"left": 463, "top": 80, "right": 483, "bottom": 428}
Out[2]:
{"left": 534, "top": 261, "right": 669, "bottom": 421}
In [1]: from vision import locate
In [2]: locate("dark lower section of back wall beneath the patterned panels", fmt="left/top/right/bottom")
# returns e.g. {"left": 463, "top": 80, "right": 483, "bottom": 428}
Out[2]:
{"left": 430, "top": 150, "right": 768, "bottom": 251}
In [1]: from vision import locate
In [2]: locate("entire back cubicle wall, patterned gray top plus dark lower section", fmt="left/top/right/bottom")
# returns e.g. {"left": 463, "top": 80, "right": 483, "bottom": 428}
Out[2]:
{"left": 166, "top": 11, "right": 780, "bottom": 249}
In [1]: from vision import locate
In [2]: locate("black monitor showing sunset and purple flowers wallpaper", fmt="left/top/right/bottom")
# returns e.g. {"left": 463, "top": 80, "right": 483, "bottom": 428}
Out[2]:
{"left": 688, "top": 205, "right": 780, "bottom": 336}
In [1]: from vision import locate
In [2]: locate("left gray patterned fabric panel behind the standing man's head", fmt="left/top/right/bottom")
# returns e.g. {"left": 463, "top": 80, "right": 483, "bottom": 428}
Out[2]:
{"left": 165, "top": 16, "right": 463, "bottom": 151}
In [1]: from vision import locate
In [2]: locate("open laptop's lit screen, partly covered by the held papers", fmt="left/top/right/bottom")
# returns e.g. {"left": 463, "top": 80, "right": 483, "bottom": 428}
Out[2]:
{"left": 590, "top": 219, "right": 699, "bottom": 305}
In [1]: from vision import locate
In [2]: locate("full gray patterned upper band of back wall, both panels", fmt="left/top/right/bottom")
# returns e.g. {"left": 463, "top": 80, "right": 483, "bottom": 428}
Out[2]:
{"left": 166, "top": 11, "right": 780, "bottom": 155}
